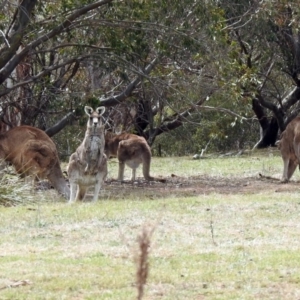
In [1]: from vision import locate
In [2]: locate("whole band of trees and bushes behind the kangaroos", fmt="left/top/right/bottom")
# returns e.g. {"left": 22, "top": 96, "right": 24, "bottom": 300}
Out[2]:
{"left": 0, "top": 0, "right": 300, "bottom": 158}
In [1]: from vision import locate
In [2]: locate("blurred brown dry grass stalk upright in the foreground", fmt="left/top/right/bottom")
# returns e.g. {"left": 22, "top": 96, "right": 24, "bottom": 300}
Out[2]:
{"left": 136, "top": 227, "right": 155, "bottom": 300}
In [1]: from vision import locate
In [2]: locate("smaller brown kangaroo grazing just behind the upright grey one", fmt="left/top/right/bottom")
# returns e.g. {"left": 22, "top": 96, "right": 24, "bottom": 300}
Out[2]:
{"left": 105, "top": 132, "right": 166, "bottom": 182}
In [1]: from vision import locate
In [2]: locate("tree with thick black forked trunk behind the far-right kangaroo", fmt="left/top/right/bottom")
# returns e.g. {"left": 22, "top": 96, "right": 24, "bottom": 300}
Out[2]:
{"left": 213, "top": 0, "right": 300, "bottom": 148}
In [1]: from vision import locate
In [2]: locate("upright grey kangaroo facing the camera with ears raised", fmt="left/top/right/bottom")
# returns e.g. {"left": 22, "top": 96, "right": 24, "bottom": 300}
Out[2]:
{"left": 67, "top": 106, "right": 107, "bottom": 203}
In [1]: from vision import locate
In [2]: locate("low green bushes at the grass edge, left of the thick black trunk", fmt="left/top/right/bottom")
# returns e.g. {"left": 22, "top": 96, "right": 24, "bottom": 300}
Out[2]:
{"left": 152, "top": 112, "right": 259, "bottom": 156}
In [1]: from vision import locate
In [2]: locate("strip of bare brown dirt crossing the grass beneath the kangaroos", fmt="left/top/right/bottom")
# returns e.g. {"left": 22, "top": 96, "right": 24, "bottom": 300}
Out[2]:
{"left": 105, "top": 174, "right": 300, "bottom": 197}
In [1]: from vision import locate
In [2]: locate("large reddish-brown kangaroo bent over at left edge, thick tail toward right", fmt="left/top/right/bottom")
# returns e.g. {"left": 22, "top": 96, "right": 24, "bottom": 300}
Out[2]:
{"left": 0, "top": 126, "right": 70, "bottom": 198}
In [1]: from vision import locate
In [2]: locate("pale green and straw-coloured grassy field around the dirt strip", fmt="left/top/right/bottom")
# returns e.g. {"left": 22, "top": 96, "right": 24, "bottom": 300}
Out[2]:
{"left": 0, "top": 150, "right": 300, "bottom": 300}
